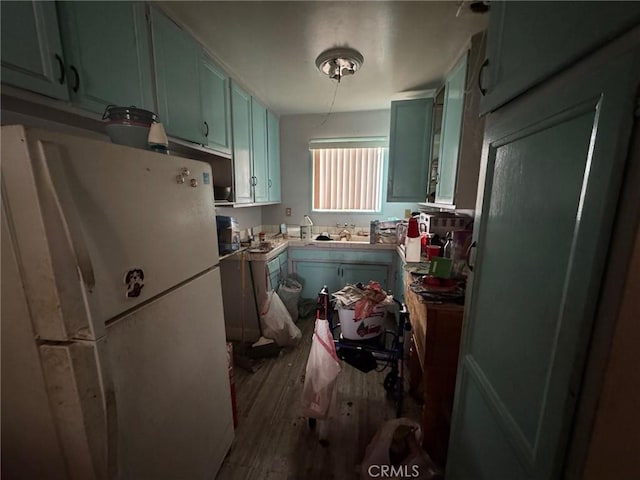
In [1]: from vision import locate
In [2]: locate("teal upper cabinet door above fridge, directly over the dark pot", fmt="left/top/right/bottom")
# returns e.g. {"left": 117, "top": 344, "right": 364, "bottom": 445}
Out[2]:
{"left": 58, "top": 2, "right": 155, "bottom": 113}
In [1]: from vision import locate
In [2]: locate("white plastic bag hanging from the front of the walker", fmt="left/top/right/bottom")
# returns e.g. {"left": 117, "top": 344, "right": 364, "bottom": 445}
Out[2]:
{"left": 302, "top": 318, "right": 340, "bottom": 419}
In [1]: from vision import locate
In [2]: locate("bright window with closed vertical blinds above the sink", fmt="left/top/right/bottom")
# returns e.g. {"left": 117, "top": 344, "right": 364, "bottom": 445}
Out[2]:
{"left": 311, "top": 139, "right": 386, "bottom": 212}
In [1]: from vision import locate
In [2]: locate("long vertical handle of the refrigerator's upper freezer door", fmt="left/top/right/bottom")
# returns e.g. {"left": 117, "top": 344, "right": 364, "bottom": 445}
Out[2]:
{"left": 38, "top": 142, "right": 96, "bottom": 292}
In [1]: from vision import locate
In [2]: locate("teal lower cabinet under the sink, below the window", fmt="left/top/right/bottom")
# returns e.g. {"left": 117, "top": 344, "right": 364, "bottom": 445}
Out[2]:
{"left": 289, "top": 247, "right": 396, "bottom": 298}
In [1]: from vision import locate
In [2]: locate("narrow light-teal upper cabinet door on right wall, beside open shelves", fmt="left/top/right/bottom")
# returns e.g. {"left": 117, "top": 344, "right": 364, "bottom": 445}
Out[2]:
{"left": 436, "top": 54, "right": 467, "bottom": 204}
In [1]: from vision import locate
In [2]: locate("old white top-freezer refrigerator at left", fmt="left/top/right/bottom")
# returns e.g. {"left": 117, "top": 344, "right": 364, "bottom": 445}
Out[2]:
{"left": 1, "top": 126, "right": 233, "bottom": 480}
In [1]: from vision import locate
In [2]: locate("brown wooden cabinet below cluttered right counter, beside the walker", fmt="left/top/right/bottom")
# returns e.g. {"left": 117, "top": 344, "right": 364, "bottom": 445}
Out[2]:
{"left": 405, "top": 273, "right": 464, "bottom": 467}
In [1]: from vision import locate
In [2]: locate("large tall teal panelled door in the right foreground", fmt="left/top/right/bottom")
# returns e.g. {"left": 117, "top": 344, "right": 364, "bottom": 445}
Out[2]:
{"left": 447, "top": 36, "right": 640, "bottom": 480}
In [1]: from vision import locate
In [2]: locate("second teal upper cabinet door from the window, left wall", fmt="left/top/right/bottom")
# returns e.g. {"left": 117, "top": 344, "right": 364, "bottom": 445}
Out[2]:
{"left": 251, "top": 97, "right": 269, "bottom": 203}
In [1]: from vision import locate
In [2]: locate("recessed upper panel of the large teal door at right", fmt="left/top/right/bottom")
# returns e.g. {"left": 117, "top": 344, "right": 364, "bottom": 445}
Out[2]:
{"left": 469, "top": 104, "right": 596, "bottom": 455}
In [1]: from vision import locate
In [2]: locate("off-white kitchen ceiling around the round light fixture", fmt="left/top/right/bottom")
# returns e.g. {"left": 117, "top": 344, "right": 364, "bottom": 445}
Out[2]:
{"left": 158, "top": 1, "right": 488, "bottom": 115}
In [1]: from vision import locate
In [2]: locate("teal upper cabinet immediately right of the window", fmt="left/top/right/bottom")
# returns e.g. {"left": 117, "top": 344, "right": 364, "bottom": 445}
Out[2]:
{"left": 387, "top": 97, "right": 433, "bottom": 202}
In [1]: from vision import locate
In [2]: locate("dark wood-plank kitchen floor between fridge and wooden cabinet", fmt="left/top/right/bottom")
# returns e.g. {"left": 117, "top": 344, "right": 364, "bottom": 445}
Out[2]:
{"left": 216, "top": 318, "right": 428, "bottom": 480}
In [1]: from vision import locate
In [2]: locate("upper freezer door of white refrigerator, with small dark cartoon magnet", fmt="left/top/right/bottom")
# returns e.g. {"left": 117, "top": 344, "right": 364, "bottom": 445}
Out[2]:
{"left": 34, "top": 134, "right": 218, "bottom": 331}
